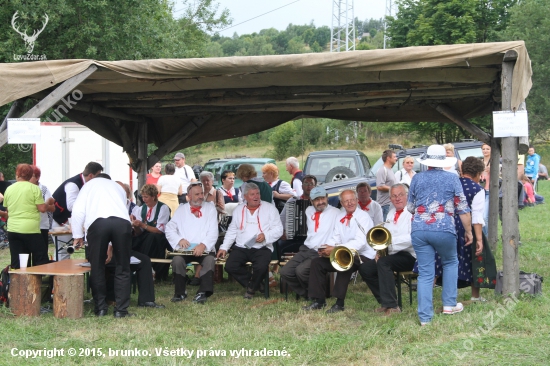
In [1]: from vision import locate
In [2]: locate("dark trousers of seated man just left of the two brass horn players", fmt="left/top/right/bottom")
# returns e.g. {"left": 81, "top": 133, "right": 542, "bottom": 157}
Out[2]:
{"left": 279, "top": 245, "right": 319, "bottom": 297}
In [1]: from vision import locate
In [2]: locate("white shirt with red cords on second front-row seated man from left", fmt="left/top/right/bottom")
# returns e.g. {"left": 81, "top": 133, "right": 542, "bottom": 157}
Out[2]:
{"left": 220, "top": 201, "right": 283, "bottom": 251}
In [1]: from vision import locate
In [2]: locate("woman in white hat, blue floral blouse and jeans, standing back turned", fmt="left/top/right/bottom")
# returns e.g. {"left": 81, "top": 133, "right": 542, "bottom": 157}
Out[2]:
{"left": 407, "top": 145, "right": 472, "bottom": 325}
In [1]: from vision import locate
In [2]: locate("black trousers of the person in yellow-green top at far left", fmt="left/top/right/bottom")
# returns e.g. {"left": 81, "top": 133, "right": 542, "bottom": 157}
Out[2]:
{"left": 8, "top": 231, "right": 50, "bottom": 269}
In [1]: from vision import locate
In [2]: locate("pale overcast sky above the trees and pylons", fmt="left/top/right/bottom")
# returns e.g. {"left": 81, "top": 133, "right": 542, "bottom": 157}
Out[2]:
{"left": 174, "top": 0, "right": 386, "bottom": 36}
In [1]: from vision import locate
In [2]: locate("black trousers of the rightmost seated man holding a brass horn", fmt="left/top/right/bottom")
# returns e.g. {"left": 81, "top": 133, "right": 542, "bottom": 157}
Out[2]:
{"left": 359, "top": 251, "right": 416, "bottom": 308}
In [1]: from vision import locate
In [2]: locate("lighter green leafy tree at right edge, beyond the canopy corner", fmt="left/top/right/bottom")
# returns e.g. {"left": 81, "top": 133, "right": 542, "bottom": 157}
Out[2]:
{"left": 501, "top": 0, "right": 550, "bottom": 141}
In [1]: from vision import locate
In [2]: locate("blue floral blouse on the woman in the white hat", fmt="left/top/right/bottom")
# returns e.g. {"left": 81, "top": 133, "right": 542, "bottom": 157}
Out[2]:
{"left": 407, "top": 168, "right": 470, "bottom": 235}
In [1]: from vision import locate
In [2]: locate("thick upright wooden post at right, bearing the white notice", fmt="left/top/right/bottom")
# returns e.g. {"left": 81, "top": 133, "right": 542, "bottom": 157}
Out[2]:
{"left": 501, "top": 51, "right": 519, "bottom": 296}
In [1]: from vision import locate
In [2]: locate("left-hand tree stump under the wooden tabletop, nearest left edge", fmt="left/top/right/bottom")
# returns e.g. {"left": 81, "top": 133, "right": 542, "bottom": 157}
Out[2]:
{"left": 8, "top": 273, "right": 42, "bottom": 316}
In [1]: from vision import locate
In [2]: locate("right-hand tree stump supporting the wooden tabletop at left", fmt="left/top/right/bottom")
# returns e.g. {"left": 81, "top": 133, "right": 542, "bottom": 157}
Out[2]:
{"left": 53, "top": 274, "right": 84, "bottom": 319}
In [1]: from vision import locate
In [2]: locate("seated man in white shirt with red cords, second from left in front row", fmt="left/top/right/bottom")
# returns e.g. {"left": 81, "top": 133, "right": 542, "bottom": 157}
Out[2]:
{"left": 217, "top": 183, "right": 283, "bottom": 299}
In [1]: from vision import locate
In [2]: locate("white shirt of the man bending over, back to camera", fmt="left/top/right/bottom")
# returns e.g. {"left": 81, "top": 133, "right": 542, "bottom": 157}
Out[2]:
{"left": 71, "top": 178, "right": 130, "bottom": 239}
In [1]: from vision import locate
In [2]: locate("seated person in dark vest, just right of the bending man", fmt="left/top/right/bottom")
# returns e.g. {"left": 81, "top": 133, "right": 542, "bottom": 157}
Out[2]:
{"left": 130, "top": 184, "right": 170, "bottom": 279}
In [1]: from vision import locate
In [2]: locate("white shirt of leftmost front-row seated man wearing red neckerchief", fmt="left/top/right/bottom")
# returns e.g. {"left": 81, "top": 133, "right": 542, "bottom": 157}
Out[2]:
{"left": 165, "top": 202, "right": 218, "bottom": 253}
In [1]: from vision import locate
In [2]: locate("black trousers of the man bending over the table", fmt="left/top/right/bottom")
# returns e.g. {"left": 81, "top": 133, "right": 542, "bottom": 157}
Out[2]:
{"left": 87, "top": 216, "right": 132, "bottom": 313}
